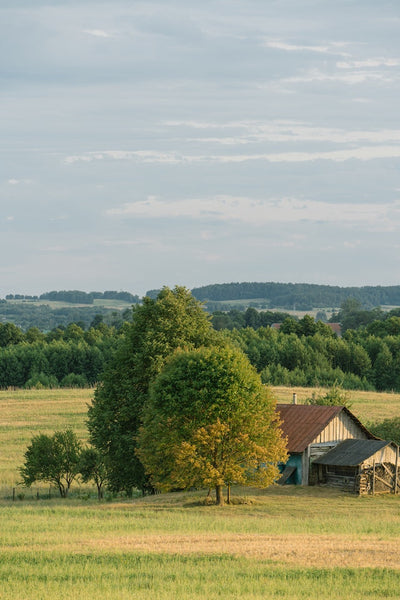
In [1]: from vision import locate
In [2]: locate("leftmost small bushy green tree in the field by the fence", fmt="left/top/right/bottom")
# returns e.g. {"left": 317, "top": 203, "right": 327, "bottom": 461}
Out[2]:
{"left": 19, "top": 429, "right": 81, "bottom": 498}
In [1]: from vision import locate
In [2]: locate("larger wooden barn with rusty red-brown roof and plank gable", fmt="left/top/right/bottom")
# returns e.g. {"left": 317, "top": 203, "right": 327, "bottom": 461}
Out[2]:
{"left": 276, "top": 404, "right": 376, "bottom": 485}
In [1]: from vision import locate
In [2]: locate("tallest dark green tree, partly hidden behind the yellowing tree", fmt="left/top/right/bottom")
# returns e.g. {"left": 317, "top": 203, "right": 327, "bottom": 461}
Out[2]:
{"left": 88, "top": 287, "right": 218, "bottom": 493}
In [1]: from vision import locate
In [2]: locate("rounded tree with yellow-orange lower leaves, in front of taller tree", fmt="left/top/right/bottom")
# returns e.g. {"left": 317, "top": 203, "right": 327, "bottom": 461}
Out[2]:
{"left": 137, "top": 347, "right": 286, "bottom": 504}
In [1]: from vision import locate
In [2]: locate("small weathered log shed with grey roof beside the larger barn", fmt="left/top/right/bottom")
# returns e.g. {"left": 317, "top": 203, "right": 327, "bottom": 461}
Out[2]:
{"left": 312, "top": 439, "right": 400, "bottom": 494}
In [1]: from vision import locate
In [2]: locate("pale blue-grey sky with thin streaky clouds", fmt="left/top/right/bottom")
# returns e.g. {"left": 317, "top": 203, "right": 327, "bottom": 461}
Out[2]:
{"left": 0, "top": 0, "right": 400, "bottom": 297}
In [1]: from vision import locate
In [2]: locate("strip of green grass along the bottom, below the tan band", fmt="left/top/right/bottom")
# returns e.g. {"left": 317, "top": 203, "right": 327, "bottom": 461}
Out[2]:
{"left": 0, "top": 553, "right": 400, "bottom": 600}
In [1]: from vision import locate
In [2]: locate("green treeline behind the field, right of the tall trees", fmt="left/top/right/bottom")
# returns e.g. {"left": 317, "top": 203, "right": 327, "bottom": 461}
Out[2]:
{"left": 227, "top": 315, "right": 400, "bottom": 391}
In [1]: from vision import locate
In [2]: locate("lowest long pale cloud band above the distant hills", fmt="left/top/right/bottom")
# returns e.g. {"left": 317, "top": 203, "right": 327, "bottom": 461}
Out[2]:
{"left": 107, "top": 196, "right": 400, "bottom": 227}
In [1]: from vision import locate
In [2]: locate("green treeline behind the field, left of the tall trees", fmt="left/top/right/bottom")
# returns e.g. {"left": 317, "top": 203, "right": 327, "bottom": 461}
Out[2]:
{"left": 0, "top": 318, "right": 124, "bottom": 388}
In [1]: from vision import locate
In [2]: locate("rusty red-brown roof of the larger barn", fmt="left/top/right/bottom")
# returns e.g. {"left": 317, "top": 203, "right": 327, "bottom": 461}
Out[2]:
{"left": 276, "top": 404, "right": 376, "bottom": 452}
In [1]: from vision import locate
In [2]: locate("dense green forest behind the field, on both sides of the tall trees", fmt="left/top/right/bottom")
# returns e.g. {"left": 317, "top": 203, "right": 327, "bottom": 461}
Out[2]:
{"left": 0, "top": 299, "right": 400, "bottom": 391}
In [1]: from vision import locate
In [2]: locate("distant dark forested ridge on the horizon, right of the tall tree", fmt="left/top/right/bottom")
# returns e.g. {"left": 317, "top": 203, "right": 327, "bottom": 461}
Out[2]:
{"left": 192, "top": 282, "right": 400, "bottom": 310}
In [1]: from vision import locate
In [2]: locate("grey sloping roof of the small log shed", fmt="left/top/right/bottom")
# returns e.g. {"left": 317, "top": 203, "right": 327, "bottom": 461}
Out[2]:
{"left": 314, "top": 440, "right": 392, "bottom": 467}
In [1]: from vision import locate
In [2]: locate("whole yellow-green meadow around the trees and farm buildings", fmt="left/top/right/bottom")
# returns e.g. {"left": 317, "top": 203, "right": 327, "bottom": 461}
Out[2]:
{"left": 0, "top": 388, "right": 400, "bottom": 600}
